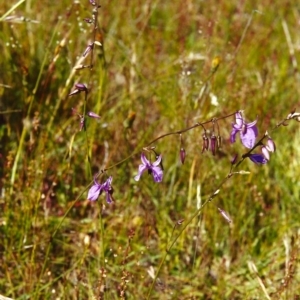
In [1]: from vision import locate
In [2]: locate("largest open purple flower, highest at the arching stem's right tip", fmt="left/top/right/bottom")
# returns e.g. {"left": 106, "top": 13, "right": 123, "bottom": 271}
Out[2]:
{"left": 230, "top": 111, "right": 258, "bottom": 149}
